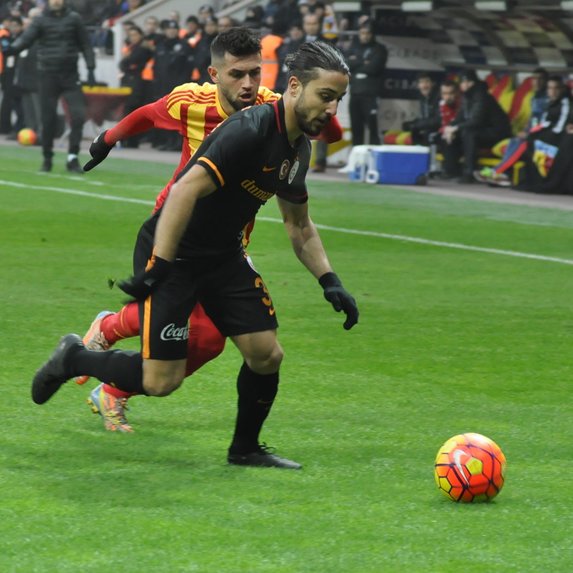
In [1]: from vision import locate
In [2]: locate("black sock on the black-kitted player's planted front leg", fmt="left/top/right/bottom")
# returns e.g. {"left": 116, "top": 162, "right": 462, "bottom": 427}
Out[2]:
{"left": 229, "top": 363, "right": 279, "bottom": 454}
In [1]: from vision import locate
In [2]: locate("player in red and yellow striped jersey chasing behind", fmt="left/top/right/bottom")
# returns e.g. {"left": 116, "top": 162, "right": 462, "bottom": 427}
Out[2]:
{"left": 76, "top": 28, "right": 342, "bottom": 432}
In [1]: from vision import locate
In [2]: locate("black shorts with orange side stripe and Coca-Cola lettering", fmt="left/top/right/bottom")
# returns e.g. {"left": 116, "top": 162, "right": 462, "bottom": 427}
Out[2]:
{"left": 134, "top": 228, "right": 278, "bottom": 360}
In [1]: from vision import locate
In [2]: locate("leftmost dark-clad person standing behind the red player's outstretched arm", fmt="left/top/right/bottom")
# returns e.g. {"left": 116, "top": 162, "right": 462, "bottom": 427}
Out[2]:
{"left": 119, "top": 26, "right": 153, "bottom": 148}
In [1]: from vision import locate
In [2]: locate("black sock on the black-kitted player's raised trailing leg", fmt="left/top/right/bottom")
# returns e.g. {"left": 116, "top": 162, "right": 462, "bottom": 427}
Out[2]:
{"left": 73, "top": 348, "right": 147, "bottom": 394}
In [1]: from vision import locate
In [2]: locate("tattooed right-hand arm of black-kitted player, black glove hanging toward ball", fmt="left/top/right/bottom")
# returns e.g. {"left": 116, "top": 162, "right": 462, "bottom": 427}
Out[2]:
{"left": 277, "top": 197, "right": 358, "bottom": 330}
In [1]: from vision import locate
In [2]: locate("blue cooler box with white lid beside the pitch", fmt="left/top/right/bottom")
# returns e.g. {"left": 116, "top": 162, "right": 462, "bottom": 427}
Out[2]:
{"left": 366, "top": 145, "right": 430, "bottom": 185}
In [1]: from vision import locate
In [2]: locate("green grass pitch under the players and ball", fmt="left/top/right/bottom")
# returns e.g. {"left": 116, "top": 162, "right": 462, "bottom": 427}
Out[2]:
{"left": 0, "top": 147, "right": 573, "bottom": 573}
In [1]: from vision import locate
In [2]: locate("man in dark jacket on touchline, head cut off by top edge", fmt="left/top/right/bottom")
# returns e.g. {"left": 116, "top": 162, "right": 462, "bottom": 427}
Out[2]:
{"left": 4, "top": 0, "right": 95, "bottom": 173}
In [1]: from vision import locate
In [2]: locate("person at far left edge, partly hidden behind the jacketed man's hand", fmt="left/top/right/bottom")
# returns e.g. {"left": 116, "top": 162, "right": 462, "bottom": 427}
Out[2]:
{"left": 0, "top": 16, "right": 24, "bottom": 139}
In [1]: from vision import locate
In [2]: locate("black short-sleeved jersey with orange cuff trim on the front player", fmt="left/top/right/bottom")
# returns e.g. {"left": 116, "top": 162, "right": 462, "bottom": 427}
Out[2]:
{"left": 150, "top": 99, "right": 310, "bottom": 259}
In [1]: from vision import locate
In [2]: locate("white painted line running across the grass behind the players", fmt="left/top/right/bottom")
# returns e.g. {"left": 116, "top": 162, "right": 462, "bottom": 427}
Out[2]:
{"left": 0, "top": 179, "right": 573, "bottom": 265}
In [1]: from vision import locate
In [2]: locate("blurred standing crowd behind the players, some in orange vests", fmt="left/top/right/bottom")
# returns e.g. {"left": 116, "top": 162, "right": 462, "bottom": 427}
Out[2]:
{"left": 0, "top": 0, "right": 387, "bottom": 159}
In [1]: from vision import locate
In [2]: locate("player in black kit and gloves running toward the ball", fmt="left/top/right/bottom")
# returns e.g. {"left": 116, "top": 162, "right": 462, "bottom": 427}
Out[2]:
{"left": 32, "top": 42, "right": 358, "bottom": 469}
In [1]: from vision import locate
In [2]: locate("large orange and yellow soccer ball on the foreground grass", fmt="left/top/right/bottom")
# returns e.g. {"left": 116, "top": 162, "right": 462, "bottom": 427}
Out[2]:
{"left": 434, "top": 434, "right": 505, "bottom": 503}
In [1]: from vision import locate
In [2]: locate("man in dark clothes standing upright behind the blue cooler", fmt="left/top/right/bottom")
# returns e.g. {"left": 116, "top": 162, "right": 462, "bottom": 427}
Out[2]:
{"left": 346, "top": 21, "right": 388, "bottom": 145}
